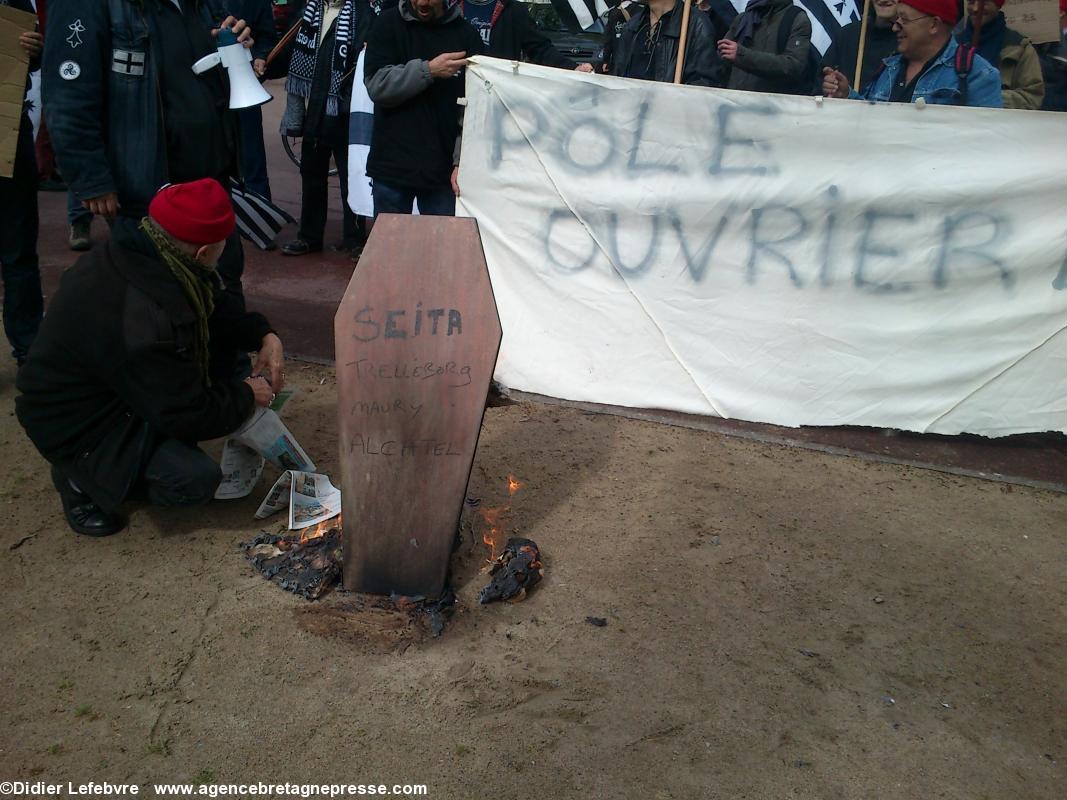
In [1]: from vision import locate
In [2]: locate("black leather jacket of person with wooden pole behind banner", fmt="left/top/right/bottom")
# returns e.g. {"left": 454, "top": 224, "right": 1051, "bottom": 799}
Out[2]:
{"left": 610, "top": 0, "right": 719, "bottom": 86}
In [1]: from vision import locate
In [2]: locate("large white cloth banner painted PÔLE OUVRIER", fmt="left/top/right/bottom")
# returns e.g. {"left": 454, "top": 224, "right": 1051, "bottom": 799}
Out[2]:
{"left": 460, "top": 59, "right": 1067, "bottom": 436}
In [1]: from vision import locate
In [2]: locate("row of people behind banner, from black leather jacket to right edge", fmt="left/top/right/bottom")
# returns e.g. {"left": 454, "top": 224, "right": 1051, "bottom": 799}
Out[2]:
{"left": 600, "top": 0, "right": 1067, "bottom": 111}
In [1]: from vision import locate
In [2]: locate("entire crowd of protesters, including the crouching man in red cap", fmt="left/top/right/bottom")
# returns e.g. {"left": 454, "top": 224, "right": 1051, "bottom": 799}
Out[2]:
{"left": 0, "top": 0, "right": 1067, "bottom": 535}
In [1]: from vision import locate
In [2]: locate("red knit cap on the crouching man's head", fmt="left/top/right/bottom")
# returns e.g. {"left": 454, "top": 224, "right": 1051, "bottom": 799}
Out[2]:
{"left": 148, "top": 178, "right": 237, "bottom": 246}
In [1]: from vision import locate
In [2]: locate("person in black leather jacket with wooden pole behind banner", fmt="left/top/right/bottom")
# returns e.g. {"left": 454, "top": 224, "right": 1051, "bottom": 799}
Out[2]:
{"left": 610, "top": 0, "right": 719, "bottom": 86}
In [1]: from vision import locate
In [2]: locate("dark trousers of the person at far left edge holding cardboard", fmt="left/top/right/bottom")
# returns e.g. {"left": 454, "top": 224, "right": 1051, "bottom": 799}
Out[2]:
{"left": 0, "top": 114, "right": 44, "bottom": 359}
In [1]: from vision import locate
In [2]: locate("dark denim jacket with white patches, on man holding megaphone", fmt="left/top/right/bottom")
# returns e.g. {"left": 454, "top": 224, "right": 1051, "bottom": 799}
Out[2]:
{"left": 42, "top": 0, "right": 228, "bottom": 218}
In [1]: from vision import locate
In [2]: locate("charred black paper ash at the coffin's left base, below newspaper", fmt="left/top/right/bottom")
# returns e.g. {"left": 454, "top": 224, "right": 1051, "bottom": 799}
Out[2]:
{"left": 241, "top": 527, "right": 341, "bottom": 599}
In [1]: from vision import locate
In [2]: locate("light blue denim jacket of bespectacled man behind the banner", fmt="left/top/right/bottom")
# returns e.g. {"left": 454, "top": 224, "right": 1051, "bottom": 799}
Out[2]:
{"left": 848, "top": 39, "right": 1004, "bottom": 109}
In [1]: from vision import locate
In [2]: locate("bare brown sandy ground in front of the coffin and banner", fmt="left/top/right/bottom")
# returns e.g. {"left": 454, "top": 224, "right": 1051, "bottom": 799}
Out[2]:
{"left": 0, "top": 361, "right": 1067, "bottom": 800}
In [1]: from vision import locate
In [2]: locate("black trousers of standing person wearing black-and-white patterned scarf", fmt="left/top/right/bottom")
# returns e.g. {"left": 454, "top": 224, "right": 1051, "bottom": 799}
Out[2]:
{"left": 297, "top": 125, "right": 362, "bottom": 249}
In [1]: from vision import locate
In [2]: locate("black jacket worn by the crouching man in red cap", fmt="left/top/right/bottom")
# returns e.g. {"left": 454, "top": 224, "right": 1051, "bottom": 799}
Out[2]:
{"left": 15, "top": 223, "right": 270, "bottom": 510}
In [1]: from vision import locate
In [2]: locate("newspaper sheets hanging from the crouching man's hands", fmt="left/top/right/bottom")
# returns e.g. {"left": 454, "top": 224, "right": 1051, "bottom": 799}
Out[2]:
{"left": 214, "top": 387, "right": 305, "bottom": 500}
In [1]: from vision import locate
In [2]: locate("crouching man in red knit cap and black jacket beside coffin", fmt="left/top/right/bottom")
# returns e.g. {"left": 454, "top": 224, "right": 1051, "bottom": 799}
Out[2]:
{"left": 15, "top": 179, "right": 283, "bottom": 537}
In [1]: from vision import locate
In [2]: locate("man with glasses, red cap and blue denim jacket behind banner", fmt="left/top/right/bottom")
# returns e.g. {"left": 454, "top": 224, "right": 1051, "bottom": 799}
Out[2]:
{"left": 823, "top": 0, "right": 1004, "bottom": 109}
